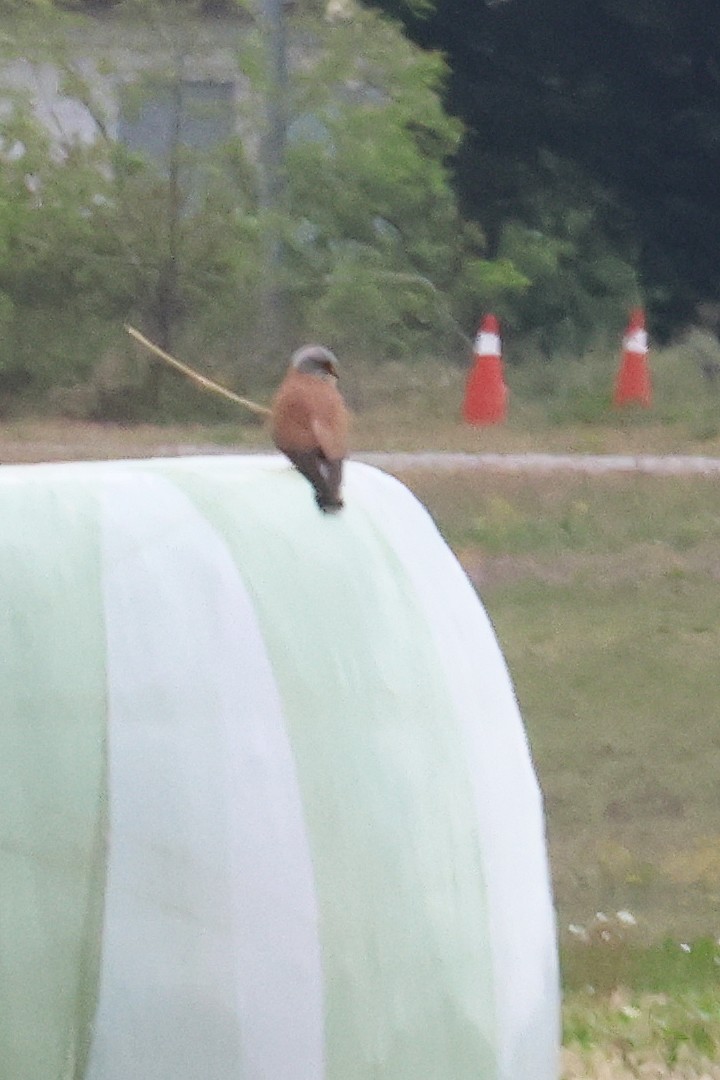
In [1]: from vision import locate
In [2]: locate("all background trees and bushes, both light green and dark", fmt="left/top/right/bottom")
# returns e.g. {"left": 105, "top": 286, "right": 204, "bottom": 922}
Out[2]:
{"left": 0, "top": 0, "right": 720, "bottom": 423}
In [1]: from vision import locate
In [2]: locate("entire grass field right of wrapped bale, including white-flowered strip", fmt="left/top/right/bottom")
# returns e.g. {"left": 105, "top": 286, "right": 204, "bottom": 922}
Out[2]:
{"left": 395, "top": 472, "right": 720, "bottom": 1080}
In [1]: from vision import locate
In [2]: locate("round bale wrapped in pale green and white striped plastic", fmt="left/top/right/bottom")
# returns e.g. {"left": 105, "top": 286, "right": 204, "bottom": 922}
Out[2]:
{"left": 0, "top": 457, "right": 558, "bottom": 1080}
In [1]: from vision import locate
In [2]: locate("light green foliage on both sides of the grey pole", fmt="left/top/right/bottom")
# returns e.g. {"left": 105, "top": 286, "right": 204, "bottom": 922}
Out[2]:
{"left": 0, "top": 5, "right": 529, "bottom": 406}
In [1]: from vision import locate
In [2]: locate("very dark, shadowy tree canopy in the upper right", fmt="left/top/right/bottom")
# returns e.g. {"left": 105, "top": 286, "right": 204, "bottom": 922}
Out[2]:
{"left": 362, "top": 0, "right": 720, "bottom": 339}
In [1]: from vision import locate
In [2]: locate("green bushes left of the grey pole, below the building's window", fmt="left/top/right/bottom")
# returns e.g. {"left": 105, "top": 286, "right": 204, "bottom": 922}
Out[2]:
{"left": 0, "top": 62, "right": 266, "bottom": 407}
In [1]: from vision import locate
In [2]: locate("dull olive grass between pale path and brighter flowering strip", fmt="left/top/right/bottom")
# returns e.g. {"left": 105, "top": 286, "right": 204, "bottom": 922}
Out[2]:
{"left": 399, "top": 473, "right": 720, "bottom": 941}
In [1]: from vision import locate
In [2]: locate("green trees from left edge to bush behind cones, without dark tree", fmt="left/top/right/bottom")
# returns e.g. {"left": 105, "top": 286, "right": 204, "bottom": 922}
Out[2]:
{"left": 0, "top": 0, "right": 651, "bottom": 414}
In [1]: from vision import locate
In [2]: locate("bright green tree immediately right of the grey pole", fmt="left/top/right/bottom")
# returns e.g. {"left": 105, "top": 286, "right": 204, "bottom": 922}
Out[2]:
{"left": 276, "top": 5, "right": 527, "bottom": 359}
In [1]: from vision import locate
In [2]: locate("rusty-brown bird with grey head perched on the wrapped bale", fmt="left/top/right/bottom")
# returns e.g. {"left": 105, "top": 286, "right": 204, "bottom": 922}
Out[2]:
{"left": 270, "top": 345, "right": 349, "bottom": 512}
